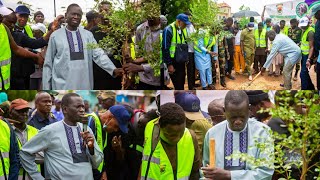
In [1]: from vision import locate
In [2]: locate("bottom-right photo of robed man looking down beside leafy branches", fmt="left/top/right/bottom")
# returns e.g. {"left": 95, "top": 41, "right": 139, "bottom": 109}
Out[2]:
{"left": 158, "top": 90, "right": 320, "bottom": 180}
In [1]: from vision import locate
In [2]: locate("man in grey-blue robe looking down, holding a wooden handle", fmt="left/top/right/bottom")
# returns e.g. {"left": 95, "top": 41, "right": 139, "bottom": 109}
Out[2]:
{"left": 201, "top": 91, "right": 274, "bottom": 180}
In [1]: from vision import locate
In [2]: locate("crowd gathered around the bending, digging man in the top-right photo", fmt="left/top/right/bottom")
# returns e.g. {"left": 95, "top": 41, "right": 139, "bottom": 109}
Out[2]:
{"left": 162, "top": 6, "right": 320, "bottom": 90}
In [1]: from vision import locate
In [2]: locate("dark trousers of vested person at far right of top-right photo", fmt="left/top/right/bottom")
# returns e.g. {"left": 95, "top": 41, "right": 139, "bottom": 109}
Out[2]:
{"left": 300, "top": 55, "right": 314, "bottom": 90}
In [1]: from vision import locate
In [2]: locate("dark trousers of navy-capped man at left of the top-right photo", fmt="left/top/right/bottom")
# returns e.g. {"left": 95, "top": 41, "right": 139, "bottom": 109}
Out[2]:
{"left": 170, "top": 62, "right": 186, "bottom": 90}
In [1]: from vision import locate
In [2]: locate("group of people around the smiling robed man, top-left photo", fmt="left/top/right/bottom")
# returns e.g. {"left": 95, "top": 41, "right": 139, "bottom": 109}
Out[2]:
{"left": 0, "top": 1, "right": 166, "bottom": 90}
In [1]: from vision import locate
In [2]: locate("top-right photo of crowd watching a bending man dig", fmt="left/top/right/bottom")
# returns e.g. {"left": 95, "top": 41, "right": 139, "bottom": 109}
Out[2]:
{"left": 161, "top": 0, "right": 320, "bottom": 90}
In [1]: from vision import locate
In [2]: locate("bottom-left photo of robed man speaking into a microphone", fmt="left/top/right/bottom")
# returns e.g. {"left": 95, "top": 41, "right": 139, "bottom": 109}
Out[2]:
{"left": 0, "top": 90, "right": 159, "bottom": 180}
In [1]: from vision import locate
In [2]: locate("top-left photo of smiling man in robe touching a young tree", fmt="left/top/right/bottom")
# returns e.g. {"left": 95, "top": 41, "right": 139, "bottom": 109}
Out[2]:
{"left": 0, "top": 0, "right": 162, "bottom": 90}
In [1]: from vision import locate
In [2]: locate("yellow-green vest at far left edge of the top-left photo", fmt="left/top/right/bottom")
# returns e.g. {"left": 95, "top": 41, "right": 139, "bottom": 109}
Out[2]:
{"left": 0, "top": 23, "right": 11, "bottom": 90}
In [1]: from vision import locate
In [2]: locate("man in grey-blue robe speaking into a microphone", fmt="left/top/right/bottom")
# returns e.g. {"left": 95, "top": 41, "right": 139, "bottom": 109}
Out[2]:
{"left": 20, "top": 93, "right": 103, "bottom": 180}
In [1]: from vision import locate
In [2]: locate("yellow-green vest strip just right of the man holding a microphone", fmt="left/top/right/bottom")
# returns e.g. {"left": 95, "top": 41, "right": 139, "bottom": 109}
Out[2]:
{"left": 88, "top": 112, "right": 108, "bottom": 172}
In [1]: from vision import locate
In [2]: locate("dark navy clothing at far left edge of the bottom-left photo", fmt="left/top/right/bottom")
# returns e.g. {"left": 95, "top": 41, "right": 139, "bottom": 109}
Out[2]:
{"left": 0, "top": 120, "right": 20, "bottom": 180}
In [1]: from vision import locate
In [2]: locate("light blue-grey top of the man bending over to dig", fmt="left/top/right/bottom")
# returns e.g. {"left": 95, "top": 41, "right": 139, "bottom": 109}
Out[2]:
{"left": 263, "top": 34, "right": 301, "bottom": 69}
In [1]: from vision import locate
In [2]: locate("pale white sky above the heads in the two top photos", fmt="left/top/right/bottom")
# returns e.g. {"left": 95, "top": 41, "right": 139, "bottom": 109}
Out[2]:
{"left": 2, "top": 0, "right": 296, "bottom": 22}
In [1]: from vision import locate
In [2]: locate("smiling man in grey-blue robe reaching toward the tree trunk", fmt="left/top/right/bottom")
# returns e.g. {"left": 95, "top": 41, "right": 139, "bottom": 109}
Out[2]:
{"left": 43, "top": 4, "right": 123, "bottom": 90}
